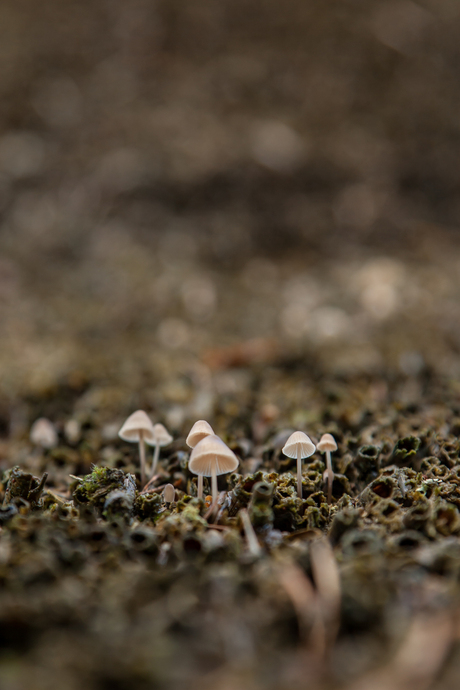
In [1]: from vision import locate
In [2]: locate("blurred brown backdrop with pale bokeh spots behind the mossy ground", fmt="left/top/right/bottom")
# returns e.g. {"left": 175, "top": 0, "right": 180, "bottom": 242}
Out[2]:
{"left": 0, "top": 0, "right": 460, "bottom": 412}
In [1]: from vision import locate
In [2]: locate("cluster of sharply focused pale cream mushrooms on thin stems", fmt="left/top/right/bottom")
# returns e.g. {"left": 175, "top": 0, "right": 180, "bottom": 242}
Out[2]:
{"left": 118, "top": 410, "right": 337, "bottom": 504}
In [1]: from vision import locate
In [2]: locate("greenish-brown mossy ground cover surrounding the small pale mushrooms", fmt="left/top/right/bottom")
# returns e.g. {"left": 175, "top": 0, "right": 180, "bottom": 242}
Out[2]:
{"left": 0, "top": 364, "right": 460, "bottom": 690}
